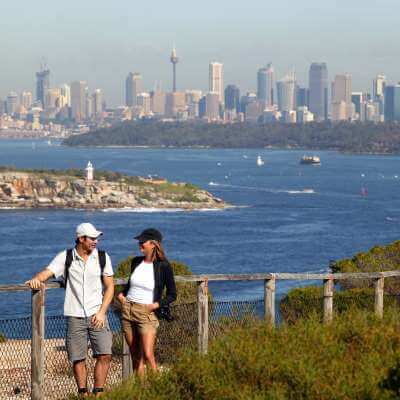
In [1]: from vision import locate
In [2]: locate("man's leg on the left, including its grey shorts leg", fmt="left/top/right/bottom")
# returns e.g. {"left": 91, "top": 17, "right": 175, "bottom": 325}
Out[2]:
{"left": 66, "top": 317, "right": 88, "bottom": 390}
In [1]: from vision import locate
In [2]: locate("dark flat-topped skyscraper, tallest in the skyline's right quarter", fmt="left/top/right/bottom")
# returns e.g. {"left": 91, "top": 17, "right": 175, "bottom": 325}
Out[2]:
{"left": 309, "top": 63, "right": 329, "bottom": 121}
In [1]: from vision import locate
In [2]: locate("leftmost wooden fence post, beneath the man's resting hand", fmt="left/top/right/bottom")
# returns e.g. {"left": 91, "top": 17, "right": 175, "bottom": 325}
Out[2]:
{"left": 31, "top": 285, "right": 45, "bottom": 400}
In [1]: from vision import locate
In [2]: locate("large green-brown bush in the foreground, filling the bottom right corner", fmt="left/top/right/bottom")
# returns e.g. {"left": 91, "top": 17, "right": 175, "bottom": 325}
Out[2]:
{"left": 99, "top": 311, "right": 400, "bottom": 400}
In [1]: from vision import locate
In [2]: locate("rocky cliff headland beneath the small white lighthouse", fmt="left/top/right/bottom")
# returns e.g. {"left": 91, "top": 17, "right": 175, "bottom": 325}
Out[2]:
{"left": 0, "top": 171, "right": 226, "bottom": 210}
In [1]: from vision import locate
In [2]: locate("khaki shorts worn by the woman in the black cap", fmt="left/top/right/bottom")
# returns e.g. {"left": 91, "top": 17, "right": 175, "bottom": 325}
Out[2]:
{"left": 121, "top": 300, "right": 160, "bottom": 334}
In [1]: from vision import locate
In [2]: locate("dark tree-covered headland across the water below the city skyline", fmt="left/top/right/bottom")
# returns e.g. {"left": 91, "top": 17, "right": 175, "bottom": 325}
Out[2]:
{"left": 63, "top": 121, "right": 400, "bottom": 153}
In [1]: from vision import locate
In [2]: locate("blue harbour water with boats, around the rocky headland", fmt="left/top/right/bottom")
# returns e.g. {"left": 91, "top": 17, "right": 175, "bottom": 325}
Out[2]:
{"left": 0, "top": 140, "right": 400, "bottom": 318}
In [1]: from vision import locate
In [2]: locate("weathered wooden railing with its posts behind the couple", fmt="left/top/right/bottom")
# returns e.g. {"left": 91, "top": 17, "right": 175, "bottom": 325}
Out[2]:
{"left": 0, "top": 270, "right": 400, "bottom": 400}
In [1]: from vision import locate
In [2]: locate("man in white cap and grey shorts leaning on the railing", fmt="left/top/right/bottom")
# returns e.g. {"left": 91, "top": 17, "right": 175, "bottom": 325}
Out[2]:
{"left": 25, "top": 222, "right": 114, "bottom": 396}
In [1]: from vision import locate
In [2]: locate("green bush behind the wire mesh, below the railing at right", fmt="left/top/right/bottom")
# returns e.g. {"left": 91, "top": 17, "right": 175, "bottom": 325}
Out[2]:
{"left": 279, "top": 286, "right": 397, "bottom": 323}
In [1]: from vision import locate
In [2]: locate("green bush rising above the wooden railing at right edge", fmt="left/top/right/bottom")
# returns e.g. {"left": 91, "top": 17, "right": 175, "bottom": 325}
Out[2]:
{"left": 330, "top": 241, "right": 400, "bottom": 294}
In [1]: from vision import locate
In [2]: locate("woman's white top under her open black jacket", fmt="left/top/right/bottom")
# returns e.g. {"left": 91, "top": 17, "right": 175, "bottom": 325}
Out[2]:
{"left": 126, "top": 261, "right": 154, "bottom": 304}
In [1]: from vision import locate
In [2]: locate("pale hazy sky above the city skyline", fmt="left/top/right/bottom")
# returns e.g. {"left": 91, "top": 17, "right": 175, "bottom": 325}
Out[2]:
{"left": 0, "top": 0, "right": 400, "bottom": 106}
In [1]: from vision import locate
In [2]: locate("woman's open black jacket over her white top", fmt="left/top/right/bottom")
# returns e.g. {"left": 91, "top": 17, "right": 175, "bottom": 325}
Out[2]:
{"left": 124, "top": 257, "right": 176, "bottom": 307}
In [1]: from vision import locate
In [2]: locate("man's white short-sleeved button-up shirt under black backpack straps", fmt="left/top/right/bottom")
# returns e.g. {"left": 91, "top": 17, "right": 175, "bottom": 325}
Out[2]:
{"left": 47, "top": 249, "right": 114, "bottom": 317}
